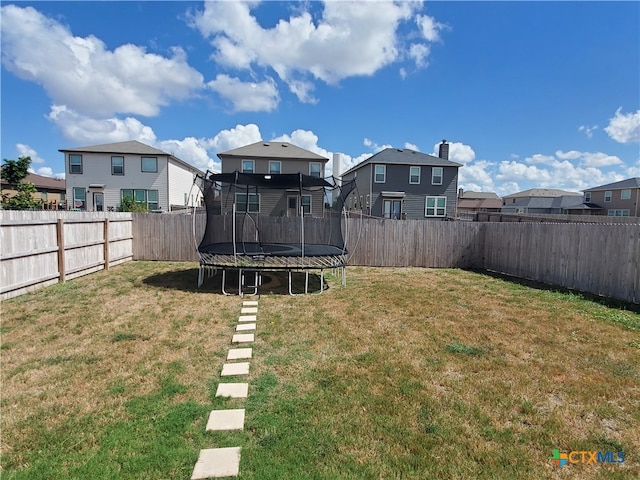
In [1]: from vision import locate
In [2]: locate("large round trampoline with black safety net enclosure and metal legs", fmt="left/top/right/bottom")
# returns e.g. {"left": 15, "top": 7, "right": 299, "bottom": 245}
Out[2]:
{"left": 196, "top": 172, "right": 355, "bottom": 296}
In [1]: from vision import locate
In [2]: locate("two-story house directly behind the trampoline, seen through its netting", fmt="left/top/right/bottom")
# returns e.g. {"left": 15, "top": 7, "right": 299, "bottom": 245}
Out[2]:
{"left": 218, "top": 141, "right": 329, "bottom": 217}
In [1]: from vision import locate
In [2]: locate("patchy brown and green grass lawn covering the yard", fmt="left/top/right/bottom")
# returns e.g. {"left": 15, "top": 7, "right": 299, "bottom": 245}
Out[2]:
{"left": 0, "top": 262, "right": 640, "bottom": 480}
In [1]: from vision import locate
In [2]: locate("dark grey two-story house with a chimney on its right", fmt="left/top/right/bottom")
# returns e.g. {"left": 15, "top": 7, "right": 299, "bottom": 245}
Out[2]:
{"left": 342, "top": 140, "right": 461, "bottom": 220}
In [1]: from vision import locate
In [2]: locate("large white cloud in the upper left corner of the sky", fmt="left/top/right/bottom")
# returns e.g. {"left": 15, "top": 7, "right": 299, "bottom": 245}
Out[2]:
{"left": 1, "top": 5, "right": 203, "bottom": 117}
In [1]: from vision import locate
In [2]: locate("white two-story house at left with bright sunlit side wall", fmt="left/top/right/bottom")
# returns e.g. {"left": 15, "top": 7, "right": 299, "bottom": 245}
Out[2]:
{"left": 60, "top": 140, "right": 203, "bottom": 212}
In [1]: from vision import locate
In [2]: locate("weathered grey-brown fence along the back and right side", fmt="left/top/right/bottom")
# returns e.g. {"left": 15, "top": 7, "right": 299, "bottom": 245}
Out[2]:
{"left": 133, "top": 214, "right": 640, "bottom": 303}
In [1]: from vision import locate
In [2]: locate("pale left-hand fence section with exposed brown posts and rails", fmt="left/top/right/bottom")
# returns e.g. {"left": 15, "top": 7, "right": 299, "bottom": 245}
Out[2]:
{"left": 0, "top": 211, "right": 133, "bottom": 299}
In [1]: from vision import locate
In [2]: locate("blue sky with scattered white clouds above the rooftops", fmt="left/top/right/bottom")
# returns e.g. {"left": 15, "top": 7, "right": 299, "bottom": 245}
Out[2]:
{"left": 1, "top": 1, "right": 640, "bottom": 195}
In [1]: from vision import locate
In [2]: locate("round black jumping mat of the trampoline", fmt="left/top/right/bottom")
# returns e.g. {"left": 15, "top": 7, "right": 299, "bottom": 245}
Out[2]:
{"left": 198, "top": 242, "right": 347, "bottom": 257}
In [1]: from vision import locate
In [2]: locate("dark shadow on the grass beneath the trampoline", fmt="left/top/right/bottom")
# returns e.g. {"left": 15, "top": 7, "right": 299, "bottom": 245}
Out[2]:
{"left": 143, "top": 268, "right": 329, "bottom": 295}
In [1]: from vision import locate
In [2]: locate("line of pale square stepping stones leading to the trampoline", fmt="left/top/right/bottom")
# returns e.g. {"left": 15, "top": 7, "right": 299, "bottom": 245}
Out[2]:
{"left": 191, "top": 300, "right": 258, "bottom": 480}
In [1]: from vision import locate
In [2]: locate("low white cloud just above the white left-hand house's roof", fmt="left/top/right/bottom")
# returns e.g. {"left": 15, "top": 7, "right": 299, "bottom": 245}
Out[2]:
{"left": 47, "top": 105, "right": 156, "bottom": 145}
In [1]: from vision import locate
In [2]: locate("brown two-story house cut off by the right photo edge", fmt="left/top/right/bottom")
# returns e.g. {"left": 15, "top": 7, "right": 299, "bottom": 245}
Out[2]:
{"left": 583, "top": 177, "right": 640, "bottom": 217}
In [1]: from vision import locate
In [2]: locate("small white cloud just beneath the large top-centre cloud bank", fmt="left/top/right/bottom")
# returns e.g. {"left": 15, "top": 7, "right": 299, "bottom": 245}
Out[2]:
{"left": 207, "top": 74, "right": 279, "bottom": 112}
